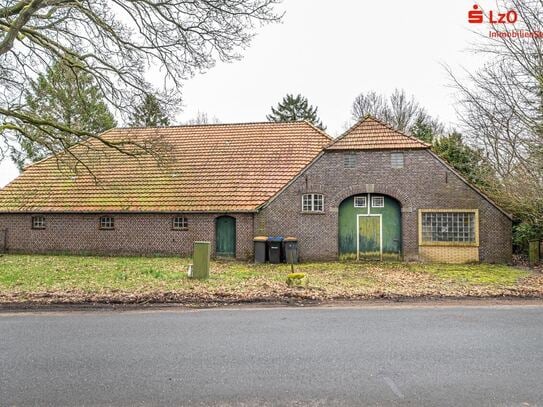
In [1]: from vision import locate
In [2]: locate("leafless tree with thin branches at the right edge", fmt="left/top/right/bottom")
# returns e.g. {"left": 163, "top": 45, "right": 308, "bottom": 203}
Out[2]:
{"left": 448, "top": 0, "right": 543, "bottom": 226}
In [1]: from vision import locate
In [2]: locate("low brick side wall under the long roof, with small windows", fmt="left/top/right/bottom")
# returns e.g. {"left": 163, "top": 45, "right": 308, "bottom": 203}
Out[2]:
{"left": 0, "top": 213, "right": 253, "bottom": 259}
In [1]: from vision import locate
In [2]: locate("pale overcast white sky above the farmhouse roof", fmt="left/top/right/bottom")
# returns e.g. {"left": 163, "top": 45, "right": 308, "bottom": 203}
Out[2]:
{"left": 0, "top": 0, "right": 495, "bottom": 186}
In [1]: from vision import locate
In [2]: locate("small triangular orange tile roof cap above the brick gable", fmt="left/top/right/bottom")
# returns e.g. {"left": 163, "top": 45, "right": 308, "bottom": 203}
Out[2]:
{"left": 327, "top": 116, "right": 430, "bottom": 150}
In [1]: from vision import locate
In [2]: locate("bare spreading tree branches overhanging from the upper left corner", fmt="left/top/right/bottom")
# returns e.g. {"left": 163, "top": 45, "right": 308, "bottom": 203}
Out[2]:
{"left": 0, "top": 0, "right": 281, "bottom": 172}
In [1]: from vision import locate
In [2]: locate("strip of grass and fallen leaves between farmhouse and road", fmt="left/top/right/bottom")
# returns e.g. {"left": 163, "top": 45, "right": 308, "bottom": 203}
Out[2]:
{"left": 0, "top": 255, "right": 543, "bottom": 304}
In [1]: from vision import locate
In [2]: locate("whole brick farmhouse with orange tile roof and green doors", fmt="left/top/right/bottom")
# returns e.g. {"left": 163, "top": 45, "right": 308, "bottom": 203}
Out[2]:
{"left": 0, "top": 117, "right": 511, "bottom": 262}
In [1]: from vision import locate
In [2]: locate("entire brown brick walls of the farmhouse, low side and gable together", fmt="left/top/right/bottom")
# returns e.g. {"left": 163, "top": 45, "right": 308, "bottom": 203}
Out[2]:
{"left": 0, "top": 150, "right": 512, "bottom": 262}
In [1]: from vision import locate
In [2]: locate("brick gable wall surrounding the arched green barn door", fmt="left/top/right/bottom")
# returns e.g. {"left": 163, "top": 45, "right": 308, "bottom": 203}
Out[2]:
{"left": 255, "top": 150, "right": 512, "bottom": 262}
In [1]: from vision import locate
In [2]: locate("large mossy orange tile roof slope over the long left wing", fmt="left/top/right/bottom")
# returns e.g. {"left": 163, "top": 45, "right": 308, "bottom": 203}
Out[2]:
{"left": 0, "top": 122, "right": 330, "bottom": 212}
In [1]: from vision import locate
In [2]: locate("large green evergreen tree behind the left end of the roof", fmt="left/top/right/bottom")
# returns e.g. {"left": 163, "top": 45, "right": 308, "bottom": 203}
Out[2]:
{"left": 12, "top": 59, "right": 116, "bottom": 170}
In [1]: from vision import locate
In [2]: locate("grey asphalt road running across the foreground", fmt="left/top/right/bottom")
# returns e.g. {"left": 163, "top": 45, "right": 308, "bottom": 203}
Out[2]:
{"left": 0, "top": 305, "right": 543, "bottom": 406}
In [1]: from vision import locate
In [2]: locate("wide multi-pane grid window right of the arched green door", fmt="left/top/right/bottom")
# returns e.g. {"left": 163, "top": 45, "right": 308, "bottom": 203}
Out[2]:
{"left": 421, "top": 210, "right": 477, "bottom": 244}
